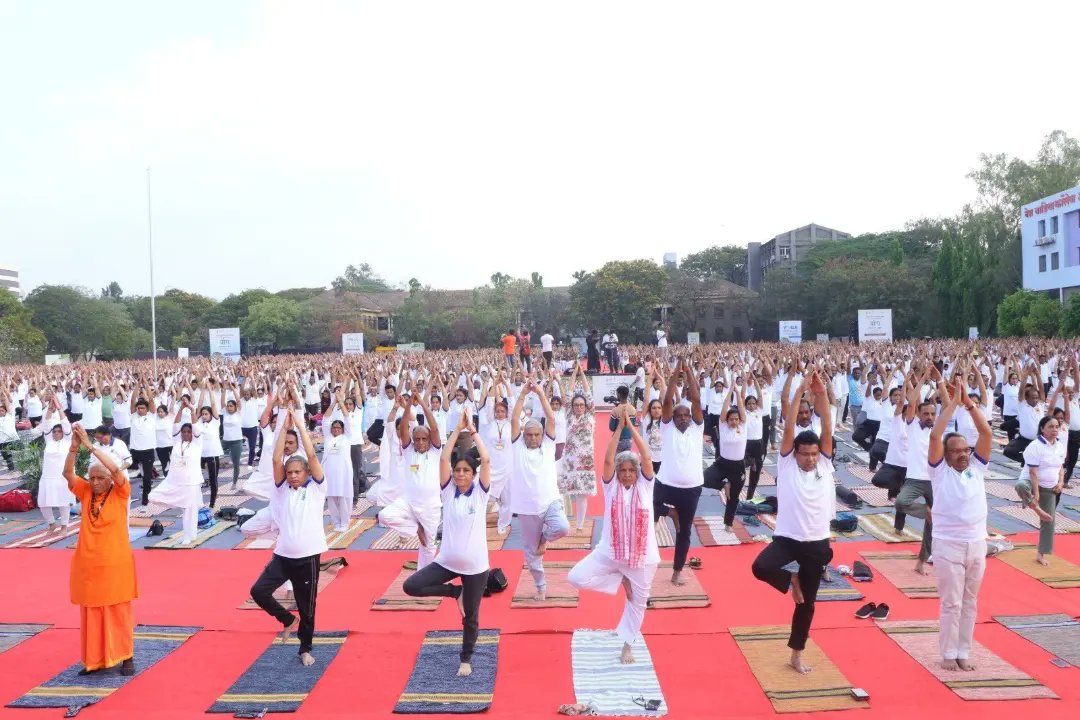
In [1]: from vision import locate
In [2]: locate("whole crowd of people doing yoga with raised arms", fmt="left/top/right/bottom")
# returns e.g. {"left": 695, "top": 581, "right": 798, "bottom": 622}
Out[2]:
{"left": 0, "top": 328, "right": 1080, "bottom": 676}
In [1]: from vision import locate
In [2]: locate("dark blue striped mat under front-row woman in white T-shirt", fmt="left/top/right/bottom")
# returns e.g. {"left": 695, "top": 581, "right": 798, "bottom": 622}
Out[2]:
{"left": 394, "top": 629, "right": 499, "bottom": 715}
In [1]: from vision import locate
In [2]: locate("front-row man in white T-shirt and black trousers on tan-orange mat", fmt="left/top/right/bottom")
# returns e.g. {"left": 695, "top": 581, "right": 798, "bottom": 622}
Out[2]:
{"left": 753, "top": 370, "right": 836, "bottom": 673}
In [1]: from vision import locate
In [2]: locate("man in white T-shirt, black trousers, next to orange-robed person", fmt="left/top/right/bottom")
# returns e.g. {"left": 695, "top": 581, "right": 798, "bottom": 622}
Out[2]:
{"left": 252, "top": 410, "right": 326, "bottom": 666}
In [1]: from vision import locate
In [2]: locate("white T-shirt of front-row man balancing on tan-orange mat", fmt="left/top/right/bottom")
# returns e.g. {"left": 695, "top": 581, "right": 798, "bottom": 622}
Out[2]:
{"left": 773, "top": 448, "right": 833, "bottom": 542}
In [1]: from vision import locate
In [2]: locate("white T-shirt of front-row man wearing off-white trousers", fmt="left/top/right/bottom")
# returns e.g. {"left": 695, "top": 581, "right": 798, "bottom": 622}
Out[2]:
{"left": 930, "top": 452, "right": 987, "bottom": 542}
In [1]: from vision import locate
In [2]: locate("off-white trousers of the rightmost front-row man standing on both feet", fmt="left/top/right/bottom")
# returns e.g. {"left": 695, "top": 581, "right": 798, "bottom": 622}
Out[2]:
{"left": 932, "top": 538, "right": 986, "bottom": 660}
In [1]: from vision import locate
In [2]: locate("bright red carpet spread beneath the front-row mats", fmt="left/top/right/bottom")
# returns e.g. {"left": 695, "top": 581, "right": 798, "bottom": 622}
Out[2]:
{"left": 0, "top": 536, "right": 1080, "bottom": 720}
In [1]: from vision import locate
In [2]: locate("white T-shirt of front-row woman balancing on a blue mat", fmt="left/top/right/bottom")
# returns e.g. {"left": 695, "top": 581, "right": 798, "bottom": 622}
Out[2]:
{"left": 435, "top": 479, "right": 488, "bottom": 575}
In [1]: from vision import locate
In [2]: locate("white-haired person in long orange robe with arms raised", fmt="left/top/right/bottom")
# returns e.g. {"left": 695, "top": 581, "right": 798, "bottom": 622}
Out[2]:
{"left": 64, "top": 424, "right": 138, "bottom": 675}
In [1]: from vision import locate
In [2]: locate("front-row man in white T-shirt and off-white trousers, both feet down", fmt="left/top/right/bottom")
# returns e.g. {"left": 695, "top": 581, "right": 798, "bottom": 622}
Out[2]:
{"left": 928, "top": 378, "right": 994, "bottom": 670}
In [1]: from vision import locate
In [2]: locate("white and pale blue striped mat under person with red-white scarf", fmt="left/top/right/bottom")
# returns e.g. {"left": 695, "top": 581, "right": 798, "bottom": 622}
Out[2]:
{"left": 570, "top": 630, "right": 667, "bottom": 718}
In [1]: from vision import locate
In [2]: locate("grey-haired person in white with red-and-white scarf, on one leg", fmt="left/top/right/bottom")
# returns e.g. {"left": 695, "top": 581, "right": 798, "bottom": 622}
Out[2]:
{"left": 567, "top": 405, "right": 660, "bottom": 664}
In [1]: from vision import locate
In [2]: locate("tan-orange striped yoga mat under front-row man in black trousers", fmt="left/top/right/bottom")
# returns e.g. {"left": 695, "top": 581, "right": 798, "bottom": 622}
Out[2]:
{"left": 731, "top": 625, "right": 869, "bottom": 712}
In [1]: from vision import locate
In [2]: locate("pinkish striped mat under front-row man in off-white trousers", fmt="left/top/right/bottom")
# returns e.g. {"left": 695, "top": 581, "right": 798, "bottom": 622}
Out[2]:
{"left": 878, "top": 620, "right": 1057, "bottom": 699}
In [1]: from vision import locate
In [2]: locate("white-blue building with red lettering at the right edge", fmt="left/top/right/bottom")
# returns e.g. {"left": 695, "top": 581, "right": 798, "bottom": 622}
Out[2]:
{"left": 1020, "top": 186, "right": 1080, "bottom": 302}
